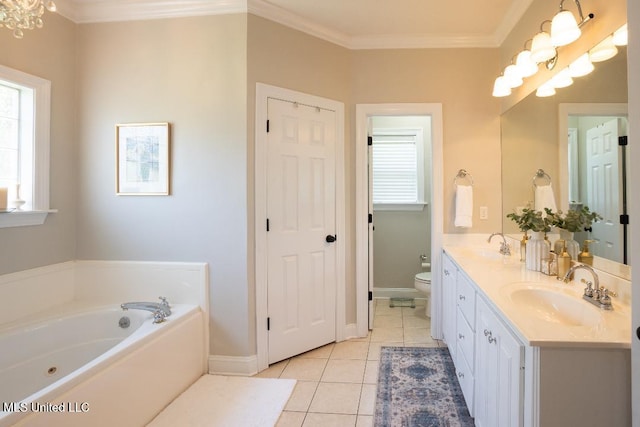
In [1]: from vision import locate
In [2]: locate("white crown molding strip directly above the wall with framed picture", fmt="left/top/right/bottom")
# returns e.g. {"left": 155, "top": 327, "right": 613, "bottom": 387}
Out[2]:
{"left": 56, "top": 0, "right": 247, "bottom": 24}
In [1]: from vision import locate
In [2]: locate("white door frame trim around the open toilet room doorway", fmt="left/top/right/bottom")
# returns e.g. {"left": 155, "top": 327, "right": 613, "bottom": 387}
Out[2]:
{"left": 356, "top": 104, "right": 443, "bottom": 339}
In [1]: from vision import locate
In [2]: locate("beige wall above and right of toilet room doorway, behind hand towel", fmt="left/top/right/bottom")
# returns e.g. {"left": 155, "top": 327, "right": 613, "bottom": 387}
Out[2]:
{"left": 352, "top": 49, "right": 502, "bottom": 233}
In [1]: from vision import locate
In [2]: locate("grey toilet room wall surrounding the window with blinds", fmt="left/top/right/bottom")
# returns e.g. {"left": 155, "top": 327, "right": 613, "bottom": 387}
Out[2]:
{"left": 372, "top": 117, "right": 431, "bottom": 288}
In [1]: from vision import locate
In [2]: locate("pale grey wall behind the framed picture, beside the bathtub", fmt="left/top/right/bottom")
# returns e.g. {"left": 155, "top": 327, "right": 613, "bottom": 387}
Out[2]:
{"left": 77, "top": 14, "right": 255, "bottom": 356}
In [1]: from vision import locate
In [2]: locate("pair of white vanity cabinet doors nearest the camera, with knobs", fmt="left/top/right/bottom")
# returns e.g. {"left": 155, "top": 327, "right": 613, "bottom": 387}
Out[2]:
{"left": 475, "top": 298, "right": 523, "bottom": 427}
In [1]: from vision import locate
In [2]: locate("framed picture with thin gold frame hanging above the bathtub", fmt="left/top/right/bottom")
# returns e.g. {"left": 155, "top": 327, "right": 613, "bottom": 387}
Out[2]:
{"left": 116, "top": 123, "right": 170, "bottom": 196}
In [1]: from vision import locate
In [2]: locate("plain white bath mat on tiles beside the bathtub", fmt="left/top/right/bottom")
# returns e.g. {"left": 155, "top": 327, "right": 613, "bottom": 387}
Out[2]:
{"left": 148, "top": 375, "right": 296, "bottom": 427}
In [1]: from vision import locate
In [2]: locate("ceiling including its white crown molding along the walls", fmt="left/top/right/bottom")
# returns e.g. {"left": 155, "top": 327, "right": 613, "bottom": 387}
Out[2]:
{"left": 51, "top": 0, "right": 533, "bottom": 49}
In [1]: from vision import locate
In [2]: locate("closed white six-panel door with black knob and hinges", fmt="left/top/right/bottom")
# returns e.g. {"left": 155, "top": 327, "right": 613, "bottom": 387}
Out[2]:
{"left": 267, "top": 98, "right": 344, "bottom": 363}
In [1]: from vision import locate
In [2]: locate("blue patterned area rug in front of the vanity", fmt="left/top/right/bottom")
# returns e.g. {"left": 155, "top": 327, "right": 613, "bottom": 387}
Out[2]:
{"left": 374, "top": 347, "right": 474, "bottom": 427}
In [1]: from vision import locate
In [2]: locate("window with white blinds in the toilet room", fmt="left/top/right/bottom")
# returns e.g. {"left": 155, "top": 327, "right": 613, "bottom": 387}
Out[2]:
{"left": 372, "top": 129, "right": 424, "bottom": 209}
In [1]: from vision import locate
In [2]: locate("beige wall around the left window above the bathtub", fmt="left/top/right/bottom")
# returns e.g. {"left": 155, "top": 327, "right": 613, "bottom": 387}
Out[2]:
{"left": 0, "top": 13, "right": 78, "bottom": 274}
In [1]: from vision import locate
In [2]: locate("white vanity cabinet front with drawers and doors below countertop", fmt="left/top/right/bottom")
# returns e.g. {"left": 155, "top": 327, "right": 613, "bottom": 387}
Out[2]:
{"left": 442, "top": 253, "right": 524, "bottom": 427}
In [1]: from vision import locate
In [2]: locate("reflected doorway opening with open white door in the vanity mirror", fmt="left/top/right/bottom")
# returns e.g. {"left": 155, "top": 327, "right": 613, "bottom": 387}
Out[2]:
{"left": 568, "top": 116, "right": 627, "bottom": 263}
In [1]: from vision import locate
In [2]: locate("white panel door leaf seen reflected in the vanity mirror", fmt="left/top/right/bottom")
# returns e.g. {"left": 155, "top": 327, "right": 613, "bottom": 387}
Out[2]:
{"left": 586, "top": 119, "right": 623, "bottom": 262}
